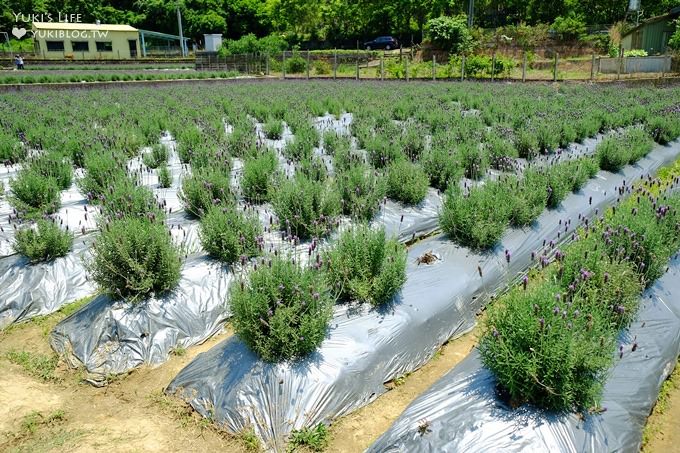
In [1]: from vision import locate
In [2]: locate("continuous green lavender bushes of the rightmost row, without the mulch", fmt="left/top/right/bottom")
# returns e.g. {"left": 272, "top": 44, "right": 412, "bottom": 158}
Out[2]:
{"left": 480, "top": 185, "right": 680, "bottom": 411}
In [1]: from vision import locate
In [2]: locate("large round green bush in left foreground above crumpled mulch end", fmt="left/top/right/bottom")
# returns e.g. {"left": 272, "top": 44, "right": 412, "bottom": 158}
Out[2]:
{"left": 86, "top": 217, "right": 181, "bottom": 303}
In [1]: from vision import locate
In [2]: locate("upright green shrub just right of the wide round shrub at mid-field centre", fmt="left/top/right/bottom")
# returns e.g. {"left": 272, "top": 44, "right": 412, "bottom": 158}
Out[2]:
{"left": 336, "top": 164, "right": 387, "bottom": 221}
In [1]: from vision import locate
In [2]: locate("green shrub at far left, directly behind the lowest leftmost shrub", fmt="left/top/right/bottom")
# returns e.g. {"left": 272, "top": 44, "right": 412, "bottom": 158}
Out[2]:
{"left": 8, "top": 168, "right": 61, "bottom": 217}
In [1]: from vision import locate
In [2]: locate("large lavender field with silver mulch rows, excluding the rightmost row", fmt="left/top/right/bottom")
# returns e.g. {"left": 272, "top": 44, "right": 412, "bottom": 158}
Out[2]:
{"left": 0, "top": 82, "right": 680, "bottom": 448}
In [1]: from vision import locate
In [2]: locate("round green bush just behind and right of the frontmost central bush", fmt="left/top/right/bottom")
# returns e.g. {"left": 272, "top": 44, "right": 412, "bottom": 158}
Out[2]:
{"left": 323, "top": 225, "right": 406, "bottom": 307}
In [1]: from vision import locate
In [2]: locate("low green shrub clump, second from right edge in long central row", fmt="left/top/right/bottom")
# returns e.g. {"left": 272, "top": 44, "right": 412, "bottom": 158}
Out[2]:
{"left": 595, "top": 128, "right": 654, "bottom": 172}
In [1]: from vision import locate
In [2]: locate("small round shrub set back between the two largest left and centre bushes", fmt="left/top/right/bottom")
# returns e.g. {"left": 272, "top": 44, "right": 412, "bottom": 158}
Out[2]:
{"left": 199, "top": 206, "right": 262, "bottom": 264}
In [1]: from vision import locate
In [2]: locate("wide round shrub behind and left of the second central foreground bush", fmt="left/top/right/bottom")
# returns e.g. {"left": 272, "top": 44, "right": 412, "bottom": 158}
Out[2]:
{"left": 272, "top": 175, "right": 341, "bottom": 238}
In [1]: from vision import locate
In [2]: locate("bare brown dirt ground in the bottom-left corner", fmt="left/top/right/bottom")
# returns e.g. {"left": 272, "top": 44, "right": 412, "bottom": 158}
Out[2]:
{"left": 0, "top": 316, "right": 246, "bottom": 453}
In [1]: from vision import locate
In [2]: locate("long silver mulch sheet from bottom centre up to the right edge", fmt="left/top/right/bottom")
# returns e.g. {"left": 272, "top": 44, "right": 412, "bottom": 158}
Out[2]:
{"left": 167, "top": 143, "right": 680, "bottom": 451}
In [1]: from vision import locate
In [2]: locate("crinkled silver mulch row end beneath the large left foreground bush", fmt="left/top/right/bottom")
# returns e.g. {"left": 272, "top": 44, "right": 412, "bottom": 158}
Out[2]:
{"left": 50, "top": 255, "right": 233, "bottom": 385}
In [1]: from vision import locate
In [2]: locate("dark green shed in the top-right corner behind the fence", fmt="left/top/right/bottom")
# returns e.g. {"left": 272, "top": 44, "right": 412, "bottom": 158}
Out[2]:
{"left": 621, "top": 7, "right": 680, "bottom": 55}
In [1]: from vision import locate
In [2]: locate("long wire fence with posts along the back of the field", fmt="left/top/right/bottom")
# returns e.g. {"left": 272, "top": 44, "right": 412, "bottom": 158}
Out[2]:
{"left": 195, "top": 51, "right": 677, "bottom": 81}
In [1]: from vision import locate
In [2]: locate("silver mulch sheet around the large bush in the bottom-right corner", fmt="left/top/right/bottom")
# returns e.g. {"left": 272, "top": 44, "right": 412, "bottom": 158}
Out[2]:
{"left": 368, "top": 257, "right": 680, "bottom": 453}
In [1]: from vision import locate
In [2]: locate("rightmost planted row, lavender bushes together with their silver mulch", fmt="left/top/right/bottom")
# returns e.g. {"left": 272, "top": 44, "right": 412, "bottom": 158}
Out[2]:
{"left": 369, "top": 167, "right": 680, "bottom": 452}
